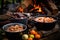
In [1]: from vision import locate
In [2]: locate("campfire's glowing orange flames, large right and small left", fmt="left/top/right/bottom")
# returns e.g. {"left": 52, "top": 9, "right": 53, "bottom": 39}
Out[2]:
{"left": 18, "top": 4, "right": 43, "bottom": 13}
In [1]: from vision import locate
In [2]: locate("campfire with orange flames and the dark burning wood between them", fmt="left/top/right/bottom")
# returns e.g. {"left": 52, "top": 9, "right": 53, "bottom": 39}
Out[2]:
{"left": 18, "top": 0, "right": 44, "bottom": 13}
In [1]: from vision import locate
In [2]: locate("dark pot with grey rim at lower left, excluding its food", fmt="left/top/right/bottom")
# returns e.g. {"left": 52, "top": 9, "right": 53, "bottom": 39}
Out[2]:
{"left": 3, "top": 23, "right": 27, "bottom": 40}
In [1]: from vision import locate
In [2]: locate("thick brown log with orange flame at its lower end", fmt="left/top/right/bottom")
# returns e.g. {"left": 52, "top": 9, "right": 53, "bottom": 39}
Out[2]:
{"left": 18, "top": 0, "right": 33, "bottom": 13}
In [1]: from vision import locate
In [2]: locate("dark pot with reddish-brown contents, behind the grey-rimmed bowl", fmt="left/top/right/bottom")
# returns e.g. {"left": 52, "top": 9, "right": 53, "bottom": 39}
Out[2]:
{"left": 10, "top": 13, "right": 28, "bottom": 25}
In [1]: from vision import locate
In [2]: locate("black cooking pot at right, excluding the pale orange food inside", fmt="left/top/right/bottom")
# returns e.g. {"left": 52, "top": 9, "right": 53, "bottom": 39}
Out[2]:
{"left": 32, "top": 16, "right": 57, "bottom": 31}
